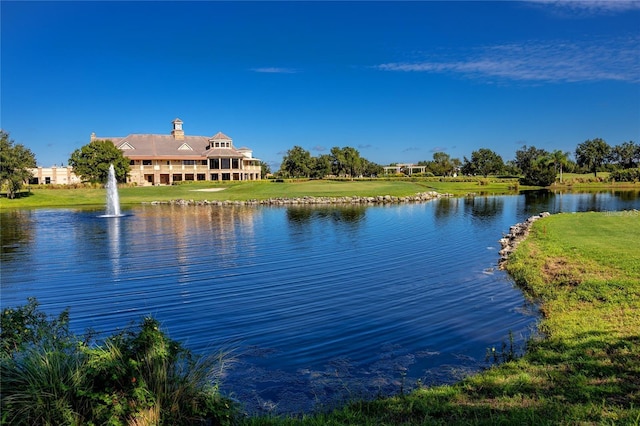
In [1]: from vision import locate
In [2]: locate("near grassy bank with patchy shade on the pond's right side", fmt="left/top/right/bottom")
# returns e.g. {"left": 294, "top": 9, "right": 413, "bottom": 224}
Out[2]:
{"left": 241, "top": 212, "right": 640, "bottom": 425}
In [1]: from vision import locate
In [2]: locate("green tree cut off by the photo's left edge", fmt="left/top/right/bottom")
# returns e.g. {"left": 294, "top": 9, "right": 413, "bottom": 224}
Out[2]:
{"left": 0, "top": 130, "right": 36, "bottom": 198}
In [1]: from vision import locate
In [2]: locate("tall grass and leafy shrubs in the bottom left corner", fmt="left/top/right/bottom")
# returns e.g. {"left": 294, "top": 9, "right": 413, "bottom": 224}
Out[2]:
{"left": 0, "top": 299, "right": 237, "bottom": 425}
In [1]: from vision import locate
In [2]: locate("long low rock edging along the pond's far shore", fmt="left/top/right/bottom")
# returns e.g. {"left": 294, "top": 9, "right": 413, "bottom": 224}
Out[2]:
{"left": 149, "top": 191, "right": 451, "bottom": 206}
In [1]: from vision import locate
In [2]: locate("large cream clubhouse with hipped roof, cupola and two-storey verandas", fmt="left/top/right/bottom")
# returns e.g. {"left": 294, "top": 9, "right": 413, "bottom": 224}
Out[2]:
{"left": 91, "top": 118, "right": 261, "bottom": 185}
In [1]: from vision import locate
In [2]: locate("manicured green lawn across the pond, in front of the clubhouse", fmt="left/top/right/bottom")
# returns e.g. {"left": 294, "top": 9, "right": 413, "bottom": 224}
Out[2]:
{"left": 0, "top": 178, "right": 515, "bottom": 209}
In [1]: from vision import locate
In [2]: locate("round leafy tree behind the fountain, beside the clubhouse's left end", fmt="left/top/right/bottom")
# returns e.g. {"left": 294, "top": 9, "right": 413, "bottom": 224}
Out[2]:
{"left": 69, "top": 140, "right": 129, "bottom": 183}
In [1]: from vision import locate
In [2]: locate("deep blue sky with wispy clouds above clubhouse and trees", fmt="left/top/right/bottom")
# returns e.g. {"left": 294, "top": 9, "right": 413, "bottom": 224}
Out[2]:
{"left": 0, "top": 0, "right": 640, "bottom": 171}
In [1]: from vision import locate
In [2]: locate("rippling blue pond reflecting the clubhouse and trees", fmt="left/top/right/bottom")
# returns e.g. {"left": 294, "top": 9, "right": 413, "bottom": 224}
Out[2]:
{"left": 0, "top": 192, "right": 640, "bottom": 413}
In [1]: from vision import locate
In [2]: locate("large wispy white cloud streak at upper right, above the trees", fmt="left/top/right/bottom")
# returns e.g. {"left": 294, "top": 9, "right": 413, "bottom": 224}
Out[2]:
{"left": 376, "top": 36, "right": 640, "bottom": 83}
